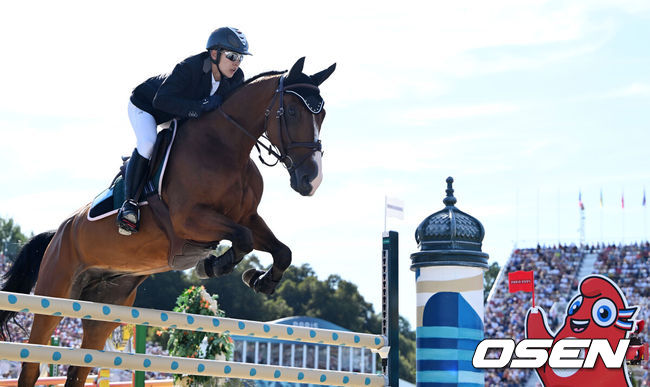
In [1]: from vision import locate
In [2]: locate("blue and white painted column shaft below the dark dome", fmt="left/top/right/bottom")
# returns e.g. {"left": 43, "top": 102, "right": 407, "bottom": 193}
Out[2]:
{"left": 416, "top": 266, "right": 484, "bottom": 387}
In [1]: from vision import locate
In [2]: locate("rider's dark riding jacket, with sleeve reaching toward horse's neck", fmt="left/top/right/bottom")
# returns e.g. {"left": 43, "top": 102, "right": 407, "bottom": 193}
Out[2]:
{"left": 131, "top": 51, "right": 244, "bottom": 124}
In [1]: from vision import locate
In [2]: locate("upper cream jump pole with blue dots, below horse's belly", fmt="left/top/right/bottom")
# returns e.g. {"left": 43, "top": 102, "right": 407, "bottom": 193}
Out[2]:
{"left": 0, "top": 291, "right": 387, "bottom": 355}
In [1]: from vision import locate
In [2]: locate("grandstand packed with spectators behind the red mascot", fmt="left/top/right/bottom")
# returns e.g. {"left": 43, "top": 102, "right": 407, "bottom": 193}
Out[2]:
{"left": 484, "top": 242, "right": 650, "bottom": 386}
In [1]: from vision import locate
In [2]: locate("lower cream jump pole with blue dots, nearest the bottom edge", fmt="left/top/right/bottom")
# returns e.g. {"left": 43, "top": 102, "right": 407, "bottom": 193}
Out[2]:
{"left": 0, "top": 343, "right": 386, "bottom": 386}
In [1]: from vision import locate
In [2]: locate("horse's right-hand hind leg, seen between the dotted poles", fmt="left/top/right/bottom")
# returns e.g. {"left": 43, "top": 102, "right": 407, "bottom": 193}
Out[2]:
{"left": 65, "top": 272, "right": 147, "bottom": 387}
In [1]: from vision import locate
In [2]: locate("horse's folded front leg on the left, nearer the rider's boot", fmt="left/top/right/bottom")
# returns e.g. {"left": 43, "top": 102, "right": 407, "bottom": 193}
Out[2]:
{"left": 186, "top": 211, "right": 253, "bottom": 278}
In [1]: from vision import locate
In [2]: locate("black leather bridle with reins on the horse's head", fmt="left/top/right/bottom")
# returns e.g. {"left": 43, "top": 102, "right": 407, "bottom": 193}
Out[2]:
{"left": 219, "top": 75, "right": 322, "bottom": 172}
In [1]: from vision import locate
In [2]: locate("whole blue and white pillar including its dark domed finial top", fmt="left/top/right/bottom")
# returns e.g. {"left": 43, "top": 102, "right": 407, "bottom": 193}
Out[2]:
{"left": 411, "top": 177, "right": 488, "bottom": 387}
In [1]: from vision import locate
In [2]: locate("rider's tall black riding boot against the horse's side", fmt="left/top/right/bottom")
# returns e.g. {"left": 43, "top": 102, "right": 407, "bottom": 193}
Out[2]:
{"left": 117, "top": 149, "right": 149, "bottom": 235}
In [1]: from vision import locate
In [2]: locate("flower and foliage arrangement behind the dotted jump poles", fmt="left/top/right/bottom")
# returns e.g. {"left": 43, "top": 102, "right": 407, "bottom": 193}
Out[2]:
{"left": 165, "top": 286, "right": 233, "bottom": 386}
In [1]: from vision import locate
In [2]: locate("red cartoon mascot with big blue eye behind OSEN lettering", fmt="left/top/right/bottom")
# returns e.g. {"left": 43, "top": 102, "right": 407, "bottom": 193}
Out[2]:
{"left": 526, "top": 275, "right": 638, "bottom": 387}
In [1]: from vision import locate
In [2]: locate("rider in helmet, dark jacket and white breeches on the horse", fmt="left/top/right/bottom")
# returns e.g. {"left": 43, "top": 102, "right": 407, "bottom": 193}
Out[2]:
{"left": 117, "top": 27, "right": 251, "bottom": 235}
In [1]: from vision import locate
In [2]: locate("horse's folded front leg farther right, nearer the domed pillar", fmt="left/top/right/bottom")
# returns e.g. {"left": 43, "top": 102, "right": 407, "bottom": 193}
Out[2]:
{"left": 242, "top": 214, "right": 291, "bottom": 294}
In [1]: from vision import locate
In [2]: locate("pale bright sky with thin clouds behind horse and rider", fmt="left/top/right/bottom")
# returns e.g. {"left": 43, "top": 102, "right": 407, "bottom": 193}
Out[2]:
{"left": 0, "top": 0, "right": 650, "bottom": 326}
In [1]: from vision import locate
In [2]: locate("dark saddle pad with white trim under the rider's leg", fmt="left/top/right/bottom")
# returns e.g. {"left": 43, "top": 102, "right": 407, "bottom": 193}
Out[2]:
{"left": 88, "top": 120, "right": 177, "bottom": 221}
